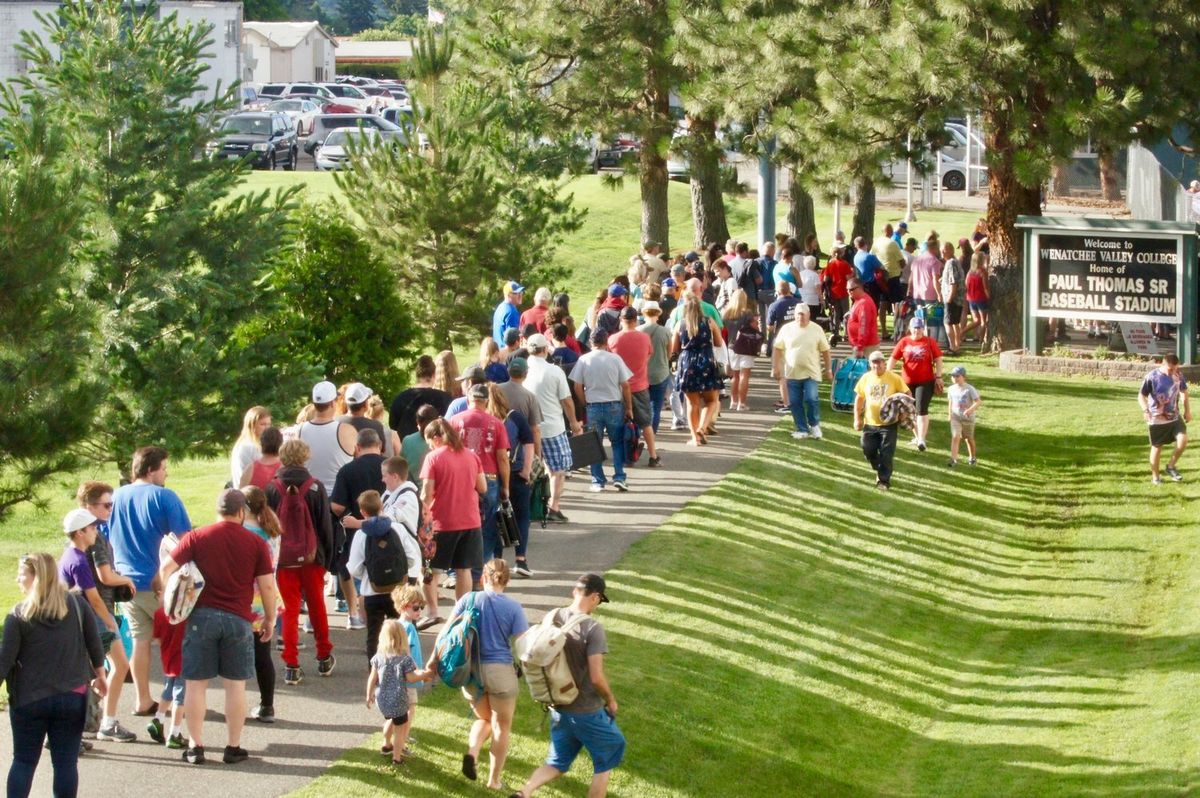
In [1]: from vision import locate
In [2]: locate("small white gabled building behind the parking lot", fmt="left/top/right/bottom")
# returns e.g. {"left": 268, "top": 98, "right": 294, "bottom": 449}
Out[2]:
{"left": 242, "top": 22, "right": 337, "bottom": 84}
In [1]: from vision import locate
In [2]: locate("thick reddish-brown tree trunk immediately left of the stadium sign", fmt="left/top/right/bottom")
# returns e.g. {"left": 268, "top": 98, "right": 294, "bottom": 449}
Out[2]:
{"left": 984, "top": 104, "right": 1042, "bottom": 352}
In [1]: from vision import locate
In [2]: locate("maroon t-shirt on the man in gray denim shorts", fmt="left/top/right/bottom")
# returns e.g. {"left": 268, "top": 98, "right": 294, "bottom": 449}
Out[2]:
{"left": 170, "top": 521, "right": 275, "bottom": 622}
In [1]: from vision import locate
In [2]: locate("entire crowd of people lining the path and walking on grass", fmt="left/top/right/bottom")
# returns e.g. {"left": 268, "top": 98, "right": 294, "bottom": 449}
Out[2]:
{"left": 0, "top": 223, "right": 1190, "bottom": 798}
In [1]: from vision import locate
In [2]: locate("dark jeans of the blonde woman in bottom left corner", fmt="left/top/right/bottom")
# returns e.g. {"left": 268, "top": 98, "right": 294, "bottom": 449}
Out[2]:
{"left": 8, "top": 692, "right": 88, "bottom": 798}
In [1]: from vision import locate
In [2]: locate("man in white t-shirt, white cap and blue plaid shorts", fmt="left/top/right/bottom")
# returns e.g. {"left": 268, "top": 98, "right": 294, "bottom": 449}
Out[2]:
{"left": 524, "top": 334, "right": 583, "bottom": 523}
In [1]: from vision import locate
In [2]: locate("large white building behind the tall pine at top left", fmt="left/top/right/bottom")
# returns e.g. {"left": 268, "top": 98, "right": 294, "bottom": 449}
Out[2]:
{"left": 0, "top": 0, "right": 242, "bottom": 102}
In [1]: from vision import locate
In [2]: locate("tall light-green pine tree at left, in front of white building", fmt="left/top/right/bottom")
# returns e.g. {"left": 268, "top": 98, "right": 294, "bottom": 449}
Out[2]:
{"left": 19, "top": 0, "right": 302, "bottom": 472}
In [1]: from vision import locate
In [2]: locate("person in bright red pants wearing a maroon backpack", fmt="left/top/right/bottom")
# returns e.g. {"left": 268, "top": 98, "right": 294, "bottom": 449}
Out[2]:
{"left": 266, "top": 439, "right": 335, "bottom": 684}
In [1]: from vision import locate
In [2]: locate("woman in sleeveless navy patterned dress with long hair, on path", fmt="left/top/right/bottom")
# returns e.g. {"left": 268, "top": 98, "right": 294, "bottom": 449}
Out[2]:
{"left": 671, "top": 292, "right": 721, "bottom": 446}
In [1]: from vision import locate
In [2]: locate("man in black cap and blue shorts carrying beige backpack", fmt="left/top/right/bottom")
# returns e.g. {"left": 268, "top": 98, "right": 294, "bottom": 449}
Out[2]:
{"left": 510, "top": 574, "right": 625, "bottom": 798}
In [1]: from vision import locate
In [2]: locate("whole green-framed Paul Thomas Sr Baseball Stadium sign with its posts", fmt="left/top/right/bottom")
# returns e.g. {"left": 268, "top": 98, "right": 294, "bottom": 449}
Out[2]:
{"left": 1016, "top": 216, "right": 1198, "bottom": 364}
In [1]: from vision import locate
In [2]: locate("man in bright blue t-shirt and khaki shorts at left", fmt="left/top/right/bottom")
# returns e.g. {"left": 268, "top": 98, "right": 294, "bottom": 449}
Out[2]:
{"left": 101, "top": 446, "right": 192, "bottom": 731}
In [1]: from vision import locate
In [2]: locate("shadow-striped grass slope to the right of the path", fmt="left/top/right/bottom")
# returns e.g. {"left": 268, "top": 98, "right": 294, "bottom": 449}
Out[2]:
{"left": 283, "top": 364, "right": 1200, "bottom": 797}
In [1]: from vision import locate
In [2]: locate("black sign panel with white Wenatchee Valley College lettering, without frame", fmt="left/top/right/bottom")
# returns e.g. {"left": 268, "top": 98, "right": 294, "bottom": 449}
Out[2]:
{"left": 1031, "top": 233, "right": 1182, "bottom": 323}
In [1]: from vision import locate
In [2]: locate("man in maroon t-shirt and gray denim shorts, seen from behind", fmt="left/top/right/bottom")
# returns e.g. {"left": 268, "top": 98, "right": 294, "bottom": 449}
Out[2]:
{"left": 158, "top": 490, "right": 276, "bottom": 764}
